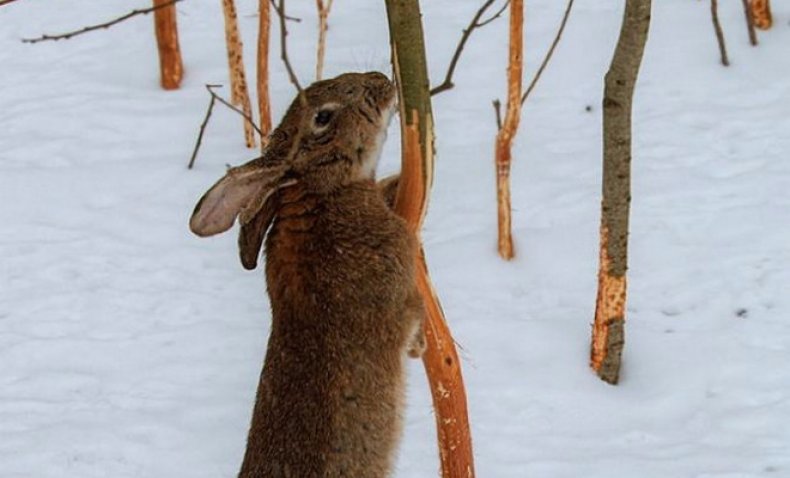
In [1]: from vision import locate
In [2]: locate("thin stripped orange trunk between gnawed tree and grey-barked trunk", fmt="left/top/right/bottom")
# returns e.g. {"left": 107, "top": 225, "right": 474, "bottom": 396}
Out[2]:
{"left": 495, "top": 0, "right": 524, "bottom": 260}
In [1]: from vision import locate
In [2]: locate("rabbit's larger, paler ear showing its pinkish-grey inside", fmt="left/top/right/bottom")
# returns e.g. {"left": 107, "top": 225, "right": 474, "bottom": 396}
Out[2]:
{"left": 189, "top": 159, "right": 286, "bottom": 237}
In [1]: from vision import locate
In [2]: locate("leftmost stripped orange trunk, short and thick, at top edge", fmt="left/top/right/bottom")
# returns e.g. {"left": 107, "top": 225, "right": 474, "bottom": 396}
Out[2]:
{"left": 154, "top": 0, "right": 184, "bottom": 90}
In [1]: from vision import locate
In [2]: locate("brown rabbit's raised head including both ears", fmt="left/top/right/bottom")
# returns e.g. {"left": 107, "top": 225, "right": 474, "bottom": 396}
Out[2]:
{"left": 189, "top": 72, "right": 396, "bottom": 268}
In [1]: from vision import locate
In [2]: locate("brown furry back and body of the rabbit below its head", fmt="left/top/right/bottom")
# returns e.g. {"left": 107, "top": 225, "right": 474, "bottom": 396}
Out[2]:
{"left": 242, "top": 182, "right": 415, "bottom": 477}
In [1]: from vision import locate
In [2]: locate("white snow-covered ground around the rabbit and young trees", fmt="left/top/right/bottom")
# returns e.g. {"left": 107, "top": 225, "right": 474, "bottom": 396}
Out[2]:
{"left": 0, "top": 0, "right": 790, "bottom": 478}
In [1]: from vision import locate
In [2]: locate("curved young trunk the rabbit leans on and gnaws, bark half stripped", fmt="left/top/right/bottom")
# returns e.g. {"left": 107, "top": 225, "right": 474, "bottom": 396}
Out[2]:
{"left": 385, "top": 0, "right": 474, "bottom": 478}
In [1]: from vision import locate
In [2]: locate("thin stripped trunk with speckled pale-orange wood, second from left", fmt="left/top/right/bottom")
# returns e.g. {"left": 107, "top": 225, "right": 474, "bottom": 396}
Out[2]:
{"left": 222, "top": 0, "right": 255, "bottom": 148}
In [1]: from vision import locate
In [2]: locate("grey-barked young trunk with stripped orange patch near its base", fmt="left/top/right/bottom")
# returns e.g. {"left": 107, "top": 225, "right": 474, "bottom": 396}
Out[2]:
{"left": 590, "top": 0, "right": 651, "bottom": 384}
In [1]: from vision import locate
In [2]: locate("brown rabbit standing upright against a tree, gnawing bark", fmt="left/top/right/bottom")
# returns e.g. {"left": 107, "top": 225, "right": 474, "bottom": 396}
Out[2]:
{"left": 190, "top": 72, "right": 424, "bottom": 478}
